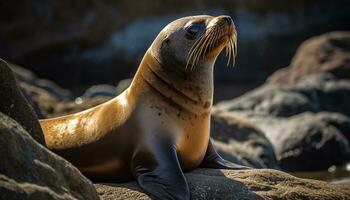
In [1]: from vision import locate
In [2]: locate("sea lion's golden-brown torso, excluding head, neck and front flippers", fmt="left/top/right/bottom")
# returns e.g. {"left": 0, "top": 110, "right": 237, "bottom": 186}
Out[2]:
{"left": 40, "top": 52, "right": 211, "bottom": 181}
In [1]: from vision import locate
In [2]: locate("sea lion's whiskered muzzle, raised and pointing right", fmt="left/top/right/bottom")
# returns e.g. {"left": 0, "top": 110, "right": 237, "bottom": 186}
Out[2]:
{"left": 186, "top": 16, "right": 237, "bottom": 70}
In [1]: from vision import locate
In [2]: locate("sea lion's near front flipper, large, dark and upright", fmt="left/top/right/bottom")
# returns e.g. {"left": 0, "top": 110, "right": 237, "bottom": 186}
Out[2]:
{"left": 131, "top": 138, "right": 190, "bottom": 200}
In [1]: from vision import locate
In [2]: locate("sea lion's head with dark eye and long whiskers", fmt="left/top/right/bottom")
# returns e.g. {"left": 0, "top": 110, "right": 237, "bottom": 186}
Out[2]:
{"left": 150, "top": 15, "right": 237, "bottom": 71}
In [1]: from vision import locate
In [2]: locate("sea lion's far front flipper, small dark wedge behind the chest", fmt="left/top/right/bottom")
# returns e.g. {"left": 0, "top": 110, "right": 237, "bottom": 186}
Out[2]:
{"left": 200, "top": 140, "right": 250, "bottom": 169}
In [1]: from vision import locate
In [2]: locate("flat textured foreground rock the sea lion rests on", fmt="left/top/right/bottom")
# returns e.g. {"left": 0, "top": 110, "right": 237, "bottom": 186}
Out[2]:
{"left": 95, "top": 169, "right": 350, "bottom": 200}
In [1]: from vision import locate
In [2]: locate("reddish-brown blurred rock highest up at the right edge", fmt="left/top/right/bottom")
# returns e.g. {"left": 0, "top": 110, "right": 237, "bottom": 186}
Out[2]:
{"left": 267, "top": 32, "right": 350, "bottom": 84}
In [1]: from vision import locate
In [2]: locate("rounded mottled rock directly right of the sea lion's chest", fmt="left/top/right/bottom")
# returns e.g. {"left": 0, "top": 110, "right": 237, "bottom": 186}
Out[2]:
{"left": 210, "top": 111, "right": 279, "bottom": 169}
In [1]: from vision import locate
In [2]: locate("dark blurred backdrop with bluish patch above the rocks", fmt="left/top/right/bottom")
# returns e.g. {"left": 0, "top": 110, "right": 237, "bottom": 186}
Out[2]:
{"left": 0, "top": 0, "right": 350, "bottom": 98}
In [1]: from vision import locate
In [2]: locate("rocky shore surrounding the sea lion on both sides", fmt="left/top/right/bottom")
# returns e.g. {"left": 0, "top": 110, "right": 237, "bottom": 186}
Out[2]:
{"left": 0, "top": 32, "right": 350, "bottom": 199}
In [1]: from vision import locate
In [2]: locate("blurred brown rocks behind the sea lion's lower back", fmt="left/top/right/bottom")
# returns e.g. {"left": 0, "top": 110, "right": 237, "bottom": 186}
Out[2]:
{"left": 9, "top": 64, "right": 112, "bottom": 119}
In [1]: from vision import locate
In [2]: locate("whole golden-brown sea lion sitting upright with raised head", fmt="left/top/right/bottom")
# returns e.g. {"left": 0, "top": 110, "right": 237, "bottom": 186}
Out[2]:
{"left": 40, "top": 15, "right": 244, "bottom": 199}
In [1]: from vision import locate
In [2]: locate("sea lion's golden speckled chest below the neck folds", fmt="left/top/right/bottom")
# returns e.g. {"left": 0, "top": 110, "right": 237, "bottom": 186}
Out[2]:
{"left": 139, "top": 97, "right": 210, "bottom": 171}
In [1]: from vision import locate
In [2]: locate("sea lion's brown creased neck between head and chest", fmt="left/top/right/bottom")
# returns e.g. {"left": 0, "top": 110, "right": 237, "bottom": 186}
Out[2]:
{"left": 130, "top": 51, "right": 213, "bottom": 114}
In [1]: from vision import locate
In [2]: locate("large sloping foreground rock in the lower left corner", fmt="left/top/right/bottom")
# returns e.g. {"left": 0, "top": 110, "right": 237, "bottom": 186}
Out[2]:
{"left": 0, "top": 112, "right": 99, "bottom": 200}
